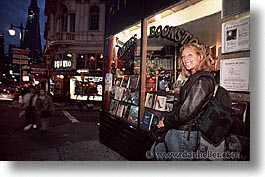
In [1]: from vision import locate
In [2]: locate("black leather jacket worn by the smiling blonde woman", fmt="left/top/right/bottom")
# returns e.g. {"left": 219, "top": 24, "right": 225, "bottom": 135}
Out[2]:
{"left": 164, "top": 71, "right": 215, "bottom": 129}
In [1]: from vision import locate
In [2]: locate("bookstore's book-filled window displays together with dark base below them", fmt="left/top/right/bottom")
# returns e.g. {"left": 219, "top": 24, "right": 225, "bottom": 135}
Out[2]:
{"left": 100, "top": 36, "right": 177, "bottom": 160}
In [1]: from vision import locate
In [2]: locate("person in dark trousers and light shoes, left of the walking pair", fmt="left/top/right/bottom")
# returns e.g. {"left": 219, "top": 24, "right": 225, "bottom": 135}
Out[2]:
{"left": 23, "top": 86, "right": 38, "bottom": 131}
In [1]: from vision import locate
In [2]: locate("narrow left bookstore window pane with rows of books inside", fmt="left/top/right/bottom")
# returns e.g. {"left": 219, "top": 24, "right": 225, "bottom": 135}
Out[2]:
{"left": 104, "top": 35, "right": 140, "bottom": 127}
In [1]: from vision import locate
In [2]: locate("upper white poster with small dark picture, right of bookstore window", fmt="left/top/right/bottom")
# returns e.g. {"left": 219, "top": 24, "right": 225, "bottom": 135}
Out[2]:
{"left": 222, "top": 18, "right": 250, "bottom": 53}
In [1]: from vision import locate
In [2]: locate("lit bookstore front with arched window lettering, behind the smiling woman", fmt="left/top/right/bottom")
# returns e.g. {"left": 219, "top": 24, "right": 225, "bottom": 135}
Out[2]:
{"left": 100, "top": 0, "right": 250, "bottom": 160}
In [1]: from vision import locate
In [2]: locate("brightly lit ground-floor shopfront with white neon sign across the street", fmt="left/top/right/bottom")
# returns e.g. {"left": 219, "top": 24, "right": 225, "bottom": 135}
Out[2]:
{"left": 49, "top": 53, "right": 103, "bottom": 104}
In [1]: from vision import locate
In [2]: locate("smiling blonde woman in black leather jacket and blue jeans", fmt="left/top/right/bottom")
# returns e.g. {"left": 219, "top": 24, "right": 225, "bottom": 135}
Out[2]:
{"left": 152, "top": 43, "right": 215, "bottom": 160}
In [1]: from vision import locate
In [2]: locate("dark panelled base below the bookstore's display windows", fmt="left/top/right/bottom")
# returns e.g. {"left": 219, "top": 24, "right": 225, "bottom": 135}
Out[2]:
{"left": 99, "top": 111, "right": 153, "bottom": 161}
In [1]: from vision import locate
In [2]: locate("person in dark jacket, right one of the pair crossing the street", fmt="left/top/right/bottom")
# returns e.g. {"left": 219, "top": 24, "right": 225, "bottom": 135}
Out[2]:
{"left": 36, "top": 89, "right": 55, "bottom": 133}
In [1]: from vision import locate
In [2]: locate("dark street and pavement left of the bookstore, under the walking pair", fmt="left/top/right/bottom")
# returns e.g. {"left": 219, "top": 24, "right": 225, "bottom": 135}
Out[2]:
{"left": 0, "top": 101, "right": 125, "bottom": 161}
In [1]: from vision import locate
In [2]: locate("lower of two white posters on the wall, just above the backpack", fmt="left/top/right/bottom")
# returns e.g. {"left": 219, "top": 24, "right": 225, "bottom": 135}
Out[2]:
{"left": 220, "top": 57, "right": 249, "bottom": 91}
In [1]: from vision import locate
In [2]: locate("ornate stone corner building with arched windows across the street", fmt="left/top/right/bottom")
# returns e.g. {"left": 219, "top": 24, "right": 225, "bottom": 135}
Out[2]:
{"left": 44, "top": 0, "right": 105, "bottom": 99}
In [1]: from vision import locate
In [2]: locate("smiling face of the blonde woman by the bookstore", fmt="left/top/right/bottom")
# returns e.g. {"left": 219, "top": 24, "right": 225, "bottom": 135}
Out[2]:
{"left": 181, "top": 47, "right": 202, "bottom": 74}
